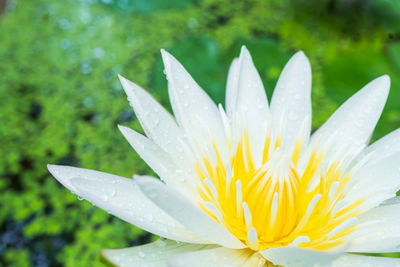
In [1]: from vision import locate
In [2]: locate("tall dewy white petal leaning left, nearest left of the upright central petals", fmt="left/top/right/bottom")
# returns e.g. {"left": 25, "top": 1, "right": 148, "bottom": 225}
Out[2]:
{"left": 161, "top": 50, "right": 228, "bottom": 163}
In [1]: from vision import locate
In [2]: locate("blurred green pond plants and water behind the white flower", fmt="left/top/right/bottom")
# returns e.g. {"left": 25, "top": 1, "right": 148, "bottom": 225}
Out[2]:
{"left": 0, "top": 0, "right": 400, "bottom": 266}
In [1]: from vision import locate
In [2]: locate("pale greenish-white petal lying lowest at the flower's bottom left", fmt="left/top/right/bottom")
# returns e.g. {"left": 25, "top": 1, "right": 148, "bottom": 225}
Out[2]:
{"left": 101, "top": 239, "right": 215, "bottom": 267}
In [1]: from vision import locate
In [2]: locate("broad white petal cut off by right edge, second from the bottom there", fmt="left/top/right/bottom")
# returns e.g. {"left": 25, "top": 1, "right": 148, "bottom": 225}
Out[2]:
{"left": 348, "top": 204, "right": 400, "bottom": 253}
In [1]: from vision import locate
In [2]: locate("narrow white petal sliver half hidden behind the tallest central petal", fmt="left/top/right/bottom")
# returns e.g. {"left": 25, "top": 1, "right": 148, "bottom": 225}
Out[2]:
{"left": 225, "top": 58, "right": 239, "bottom": 119}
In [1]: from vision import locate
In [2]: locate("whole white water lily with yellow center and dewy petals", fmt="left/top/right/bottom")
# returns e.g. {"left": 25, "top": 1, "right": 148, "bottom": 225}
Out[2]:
{"left": 49, "top": 47, "right": 400, "bottom": 267}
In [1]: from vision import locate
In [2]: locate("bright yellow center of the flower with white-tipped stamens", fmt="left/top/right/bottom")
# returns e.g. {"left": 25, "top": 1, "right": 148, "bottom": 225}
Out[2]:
{"left": 195, "top": 133, "right": 361, "bottom": 251}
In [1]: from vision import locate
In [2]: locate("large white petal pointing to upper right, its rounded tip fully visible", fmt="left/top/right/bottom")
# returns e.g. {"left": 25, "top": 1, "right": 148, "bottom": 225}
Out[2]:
{"left": 312, "top": 75, "right": 390, "bottom": 163}
